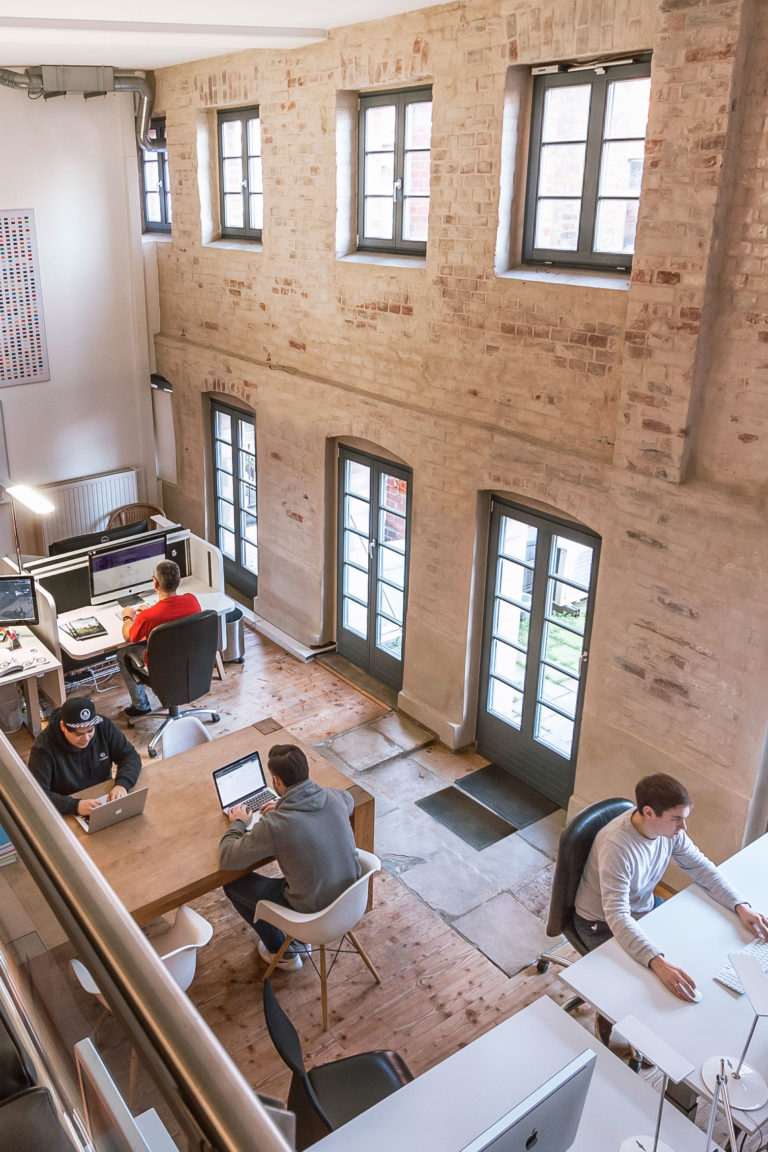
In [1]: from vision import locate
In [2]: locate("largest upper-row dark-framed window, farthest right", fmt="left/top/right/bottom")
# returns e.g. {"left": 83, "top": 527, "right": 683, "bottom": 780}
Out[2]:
{"left": 523, "top": 58, "right": 651, "bottom": 271}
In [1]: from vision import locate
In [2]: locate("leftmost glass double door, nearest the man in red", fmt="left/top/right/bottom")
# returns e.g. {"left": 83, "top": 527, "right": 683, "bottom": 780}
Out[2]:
{"left": 211, "top": 400, "right": 259, "bottom": 597}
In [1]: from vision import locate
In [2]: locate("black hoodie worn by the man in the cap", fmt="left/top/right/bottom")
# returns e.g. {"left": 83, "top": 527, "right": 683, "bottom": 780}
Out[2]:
{"left": 29, "top": 708, "right": 142, "bottom": 814}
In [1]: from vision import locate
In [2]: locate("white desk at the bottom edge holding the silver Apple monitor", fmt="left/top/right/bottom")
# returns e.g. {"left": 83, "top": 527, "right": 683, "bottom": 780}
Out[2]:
{"left": 313, "top": 996, "right": 723, "bottom": 1152}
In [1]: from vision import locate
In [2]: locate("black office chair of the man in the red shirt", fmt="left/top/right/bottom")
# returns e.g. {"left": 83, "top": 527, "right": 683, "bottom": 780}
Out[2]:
{"left": 126, "top": 612, "right": 219, "bottom": 757}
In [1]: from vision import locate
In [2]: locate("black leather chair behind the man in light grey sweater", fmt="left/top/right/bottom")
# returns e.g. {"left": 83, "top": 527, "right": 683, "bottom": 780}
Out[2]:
{"left": 538, "top": 797, "right": 634, "bottom": 972}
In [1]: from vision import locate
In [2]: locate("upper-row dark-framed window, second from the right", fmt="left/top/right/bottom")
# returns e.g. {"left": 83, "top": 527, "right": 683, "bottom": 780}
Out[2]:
{"left": 357, "top": 86, "right": 432, "bottom": 256}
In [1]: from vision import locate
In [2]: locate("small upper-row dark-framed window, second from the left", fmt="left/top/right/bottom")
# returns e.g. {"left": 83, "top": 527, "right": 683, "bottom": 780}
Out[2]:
{"left": 216, "top": 108, "right": 264, "bottom": 240}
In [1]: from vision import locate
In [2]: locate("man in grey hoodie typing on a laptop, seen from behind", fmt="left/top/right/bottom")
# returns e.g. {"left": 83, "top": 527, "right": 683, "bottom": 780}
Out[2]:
{"left": 219, "top": 744, "right": 360, "bottom": 971}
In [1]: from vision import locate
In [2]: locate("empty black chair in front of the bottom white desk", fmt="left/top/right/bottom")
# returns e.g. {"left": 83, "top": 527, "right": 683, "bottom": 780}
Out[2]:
{"left": 264, "top": 980, "right": 413, "bottom": 1152}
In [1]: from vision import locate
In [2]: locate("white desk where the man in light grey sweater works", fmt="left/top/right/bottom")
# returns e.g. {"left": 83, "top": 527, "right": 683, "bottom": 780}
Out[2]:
{"left": 561, "top": 836, "right": 768, "bottom": 1132}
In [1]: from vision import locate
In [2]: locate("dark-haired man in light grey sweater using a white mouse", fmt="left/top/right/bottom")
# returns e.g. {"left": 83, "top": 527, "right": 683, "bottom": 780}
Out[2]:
{"left": 573, "top": 773, "right": 768, "bottom": 1000}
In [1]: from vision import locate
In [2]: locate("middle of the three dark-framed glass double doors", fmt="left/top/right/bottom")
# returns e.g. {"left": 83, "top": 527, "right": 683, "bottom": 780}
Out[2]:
{"left": 336, "top": 448, "right": 411, "bottom": 690}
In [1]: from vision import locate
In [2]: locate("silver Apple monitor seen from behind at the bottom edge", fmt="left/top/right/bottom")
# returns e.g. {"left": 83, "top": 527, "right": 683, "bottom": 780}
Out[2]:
{"left": 462, "top": 1048, "right": 598, "bottom": 1152}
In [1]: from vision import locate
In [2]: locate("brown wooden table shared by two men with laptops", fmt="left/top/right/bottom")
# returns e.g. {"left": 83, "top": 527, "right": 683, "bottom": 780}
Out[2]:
{"left": 67, "top": 720, "right": 374, "bottom": 924}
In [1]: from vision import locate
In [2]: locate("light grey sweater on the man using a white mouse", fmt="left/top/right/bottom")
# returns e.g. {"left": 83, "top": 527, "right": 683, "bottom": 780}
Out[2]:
{"left": 576, "top": 811, "right": 743, "bottom": 967}
